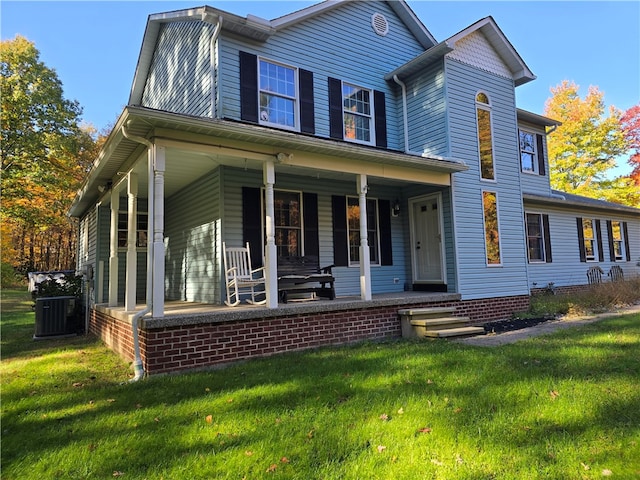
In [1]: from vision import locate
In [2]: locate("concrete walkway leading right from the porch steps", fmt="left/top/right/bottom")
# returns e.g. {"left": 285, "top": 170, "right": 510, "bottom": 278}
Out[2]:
{"left": 455, "top": 305, "right": 640, "bottom": 347}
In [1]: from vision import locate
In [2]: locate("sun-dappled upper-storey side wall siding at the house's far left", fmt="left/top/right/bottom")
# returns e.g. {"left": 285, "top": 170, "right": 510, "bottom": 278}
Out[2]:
{"left": 142, "top": 22, "right": 214, "bottom": 117}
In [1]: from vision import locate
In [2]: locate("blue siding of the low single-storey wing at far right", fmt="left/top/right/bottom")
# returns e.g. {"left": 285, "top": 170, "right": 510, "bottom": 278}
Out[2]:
{"left": 526, "top": 205, "right": 640, "bottom": 288}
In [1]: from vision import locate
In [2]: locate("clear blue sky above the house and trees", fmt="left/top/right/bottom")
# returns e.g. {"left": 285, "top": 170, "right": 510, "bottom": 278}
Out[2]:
{"left": 0, "top": 0, "right": 640, "bottom": 174}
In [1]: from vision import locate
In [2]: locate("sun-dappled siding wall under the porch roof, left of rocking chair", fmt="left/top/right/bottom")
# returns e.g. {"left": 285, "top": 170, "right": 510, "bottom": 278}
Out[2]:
{"left": 165, "top": 170, "right": 222, "bottom": 303}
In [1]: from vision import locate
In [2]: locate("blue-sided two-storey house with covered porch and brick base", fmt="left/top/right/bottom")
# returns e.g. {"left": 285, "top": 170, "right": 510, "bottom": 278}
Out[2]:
{"left": 71, "top": 0, "right": 640, "bottom": 374}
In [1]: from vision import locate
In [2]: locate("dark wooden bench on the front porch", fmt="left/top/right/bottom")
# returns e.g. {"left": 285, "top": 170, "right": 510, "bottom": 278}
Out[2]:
{"left": 278, "top": 255, "right": 336, "bottom": 303}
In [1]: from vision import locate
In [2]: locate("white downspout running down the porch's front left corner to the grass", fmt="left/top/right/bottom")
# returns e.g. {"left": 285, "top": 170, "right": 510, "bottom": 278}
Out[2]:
{"left": 122, "top": 125, "right": 154, "bottom": 382}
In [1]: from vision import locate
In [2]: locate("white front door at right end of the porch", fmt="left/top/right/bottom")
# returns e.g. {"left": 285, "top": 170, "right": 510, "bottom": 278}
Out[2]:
{"left": 410, "top": 194, "right": 445, "bottom": 284}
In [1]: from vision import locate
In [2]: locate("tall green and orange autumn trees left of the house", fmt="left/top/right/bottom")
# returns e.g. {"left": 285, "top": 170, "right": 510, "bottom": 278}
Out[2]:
{"left": 0, "top": 36, "right": 95, "bottom": 271}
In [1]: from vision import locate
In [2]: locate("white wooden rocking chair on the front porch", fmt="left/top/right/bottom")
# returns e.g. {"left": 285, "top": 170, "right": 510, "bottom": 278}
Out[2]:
{"left": 222, "top": 242, "right": 267, "bottom": 307}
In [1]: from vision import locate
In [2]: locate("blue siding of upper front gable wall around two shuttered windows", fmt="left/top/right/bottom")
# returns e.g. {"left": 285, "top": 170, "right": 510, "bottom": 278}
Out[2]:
{"left": 220, "top": 2, "right": 423, "bottom": 149}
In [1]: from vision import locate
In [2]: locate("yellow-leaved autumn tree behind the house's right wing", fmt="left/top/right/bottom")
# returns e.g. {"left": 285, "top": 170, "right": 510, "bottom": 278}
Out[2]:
{"left": 545, "top": 80, "right": 640, "bottom": 206}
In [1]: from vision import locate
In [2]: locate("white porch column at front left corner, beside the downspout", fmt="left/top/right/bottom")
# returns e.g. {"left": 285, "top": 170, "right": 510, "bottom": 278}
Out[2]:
{"left": 149, "top": 145, "right": 166, "bottom": 318}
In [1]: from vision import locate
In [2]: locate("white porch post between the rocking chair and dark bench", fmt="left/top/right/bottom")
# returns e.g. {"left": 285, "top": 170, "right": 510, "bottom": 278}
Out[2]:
{"left": 263, "top": 161, "right": 278, "bottom": 308}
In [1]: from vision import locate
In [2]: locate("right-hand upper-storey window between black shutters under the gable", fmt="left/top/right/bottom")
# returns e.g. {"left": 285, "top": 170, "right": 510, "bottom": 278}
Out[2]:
{"left": 342, "top": 82, "right": 375, "bottom": 144}
